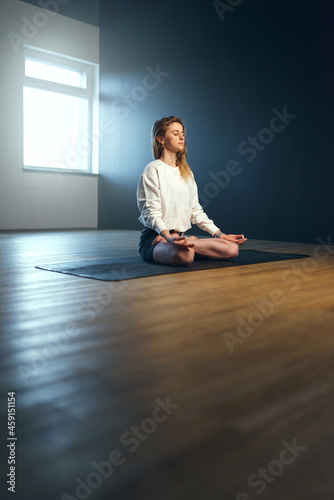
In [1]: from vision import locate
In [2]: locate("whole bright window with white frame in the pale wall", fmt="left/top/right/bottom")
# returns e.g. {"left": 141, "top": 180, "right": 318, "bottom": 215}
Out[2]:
{"left": 23, "top": 46, "right": 98, "bottom": 173}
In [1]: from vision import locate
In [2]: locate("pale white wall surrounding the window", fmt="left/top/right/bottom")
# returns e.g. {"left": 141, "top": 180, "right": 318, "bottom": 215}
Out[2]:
{"left": 0, "top": 0, "right": 99, "bottom": 230}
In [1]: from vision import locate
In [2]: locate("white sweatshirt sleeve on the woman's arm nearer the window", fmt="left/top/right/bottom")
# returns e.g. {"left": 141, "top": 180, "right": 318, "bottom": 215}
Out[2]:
{"left": 137, "top": 167, "right": 167, "bottom": 234}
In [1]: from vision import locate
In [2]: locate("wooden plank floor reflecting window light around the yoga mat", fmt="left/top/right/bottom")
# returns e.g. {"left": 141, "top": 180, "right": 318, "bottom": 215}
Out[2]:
{"left": 0, "top": 230, "right": 334, "bottom": 500}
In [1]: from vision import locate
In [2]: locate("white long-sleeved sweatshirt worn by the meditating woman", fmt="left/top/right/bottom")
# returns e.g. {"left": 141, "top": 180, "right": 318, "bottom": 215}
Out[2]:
{"left": 137, "top": 160, "right": 219, "bottom": 236}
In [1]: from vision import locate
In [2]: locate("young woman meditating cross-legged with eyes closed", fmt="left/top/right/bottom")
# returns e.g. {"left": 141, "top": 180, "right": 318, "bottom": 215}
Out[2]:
{"left": 137, "top": 116, "right": 247, "bottom": 266}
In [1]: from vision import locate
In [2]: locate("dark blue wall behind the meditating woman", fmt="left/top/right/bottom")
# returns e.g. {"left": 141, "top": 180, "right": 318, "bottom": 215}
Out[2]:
{"left": 99, "top": 0, "right": 334, "bottom": 242}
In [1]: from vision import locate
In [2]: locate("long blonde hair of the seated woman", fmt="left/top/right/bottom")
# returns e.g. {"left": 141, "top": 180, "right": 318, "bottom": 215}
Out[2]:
{"left": 152, "top": 116, "right": 193, "bottom": 181}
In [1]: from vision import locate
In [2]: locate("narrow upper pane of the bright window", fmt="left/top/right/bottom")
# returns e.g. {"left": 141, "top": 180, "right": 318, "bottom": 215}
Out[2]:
{"left": 25, "top": 59, "right": 87, "bottom": 89}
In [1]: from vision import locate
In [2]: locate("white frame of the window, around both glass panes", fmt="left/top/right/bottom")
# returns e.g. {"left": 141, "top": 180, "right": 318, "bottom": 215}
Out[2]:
{"left": 23, "top": 45, "right": 99, "bottom": 175}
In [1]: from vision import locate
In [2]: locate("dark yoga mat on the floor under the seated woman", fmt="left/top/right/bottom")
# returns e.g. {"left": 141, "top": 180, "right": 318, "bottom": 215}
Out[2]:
{"left": 35, "top": 249, "right": 310, "bottom": 281}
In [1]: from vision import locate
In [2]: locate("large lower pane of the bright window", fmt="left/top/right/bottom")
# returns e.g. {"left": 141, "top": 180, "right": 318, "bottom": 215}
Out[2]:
{"left": 23, "top": 87, "right": 90, "bottom": 170}
